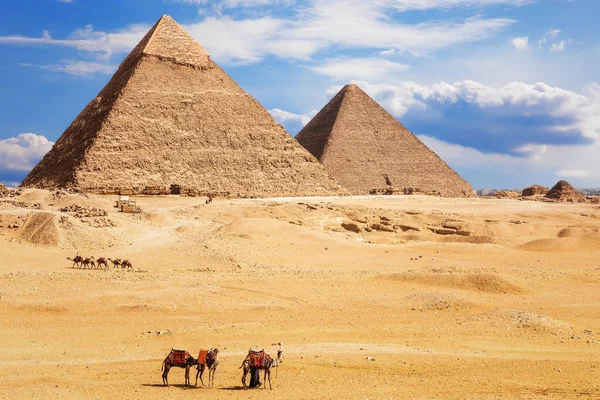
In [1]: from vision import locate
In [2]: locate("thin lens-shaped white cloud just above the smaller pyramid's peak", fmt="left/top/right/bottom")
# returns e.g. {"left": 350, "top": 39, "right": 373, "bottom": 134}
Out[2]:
{"left": 309, "top": 58, "right": 409, "bottom": 80}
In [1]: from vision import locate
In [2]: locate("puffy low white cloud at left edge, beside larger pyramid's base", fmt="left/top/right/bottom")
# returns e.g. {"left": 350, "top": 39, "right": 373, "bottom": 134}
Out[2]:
{"left": 0, "top": 133, "right": 54, "bottom": 171}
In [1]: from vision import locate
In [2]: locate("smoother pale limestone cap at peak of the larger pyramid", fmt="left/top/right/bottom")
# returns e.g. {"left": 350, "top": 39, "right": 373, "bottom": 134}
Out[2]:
{"left": 123, "top": 15, "right": 210, "bottom": 67}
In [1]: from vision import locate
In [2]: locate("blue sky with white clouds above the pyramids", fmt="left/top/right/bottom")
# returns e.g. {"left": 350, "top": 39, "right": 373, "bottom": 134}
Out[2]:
{"left": 0, "top": 0, "right": 600, "bottom": 188}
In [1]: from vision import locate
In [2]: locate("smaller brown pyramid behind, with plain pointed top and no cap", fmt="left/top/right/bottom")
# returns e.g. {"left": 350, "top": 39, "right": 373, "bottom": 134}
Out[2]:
{"left": 296, "top": 85, "right": 473, "bottom": 197}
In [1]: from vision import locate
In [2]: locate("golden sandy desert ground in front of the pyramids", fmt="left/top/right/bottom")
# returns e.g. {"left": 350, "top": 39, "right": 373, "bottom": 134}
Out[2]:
{"left": 0, "top": 191, "right": 600, "bottom": 399}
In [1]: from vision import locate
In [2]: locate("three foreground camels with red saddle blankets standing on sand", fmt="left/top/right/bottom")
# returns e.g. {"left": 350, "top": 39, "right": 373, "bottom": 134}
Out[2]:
{"left": 161, "top": 343, "right": 283, "bottom": 389}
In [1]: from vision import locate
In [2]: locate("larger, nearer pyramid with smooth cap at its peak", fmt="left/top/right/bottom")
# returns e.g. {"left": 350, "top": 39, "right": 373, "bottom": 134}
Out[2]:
{"left": 22, "top": 15, "right": 341, "bottom": 196}
